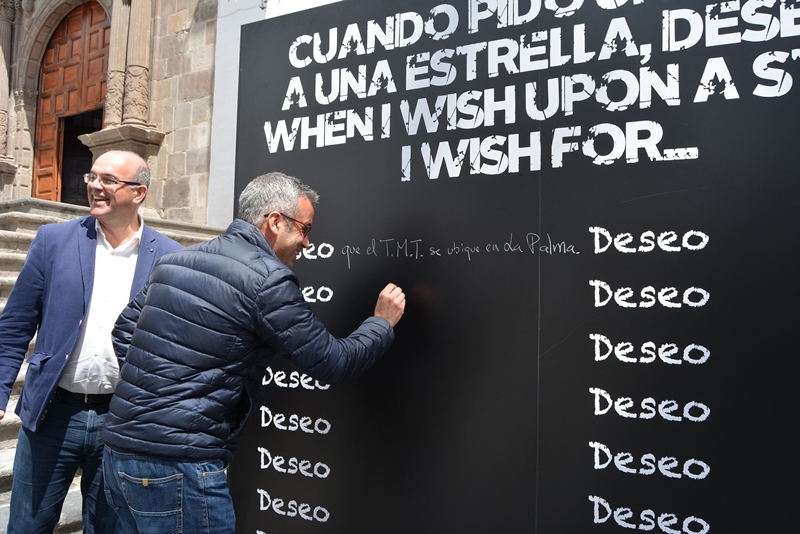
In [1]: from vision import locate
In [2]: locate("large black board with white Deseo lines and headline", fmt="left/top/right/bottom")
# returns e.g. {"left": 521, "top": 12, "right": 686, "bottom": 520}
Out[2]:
{"left": 230, "top": 0, "right": 800, "bottom": 534}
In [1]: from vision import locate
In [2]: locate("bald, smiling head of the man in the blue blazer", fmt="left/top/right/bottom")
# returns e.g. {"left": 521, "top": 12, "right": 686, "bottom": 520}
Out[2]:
{"left": 86, "top": 151, "right": 147, "bottom": 229}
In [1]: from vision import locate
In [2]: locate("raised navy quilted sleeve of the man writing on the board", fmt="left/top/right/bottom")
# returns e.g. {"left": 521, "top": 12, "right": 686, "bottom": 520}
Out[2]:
{"left": 255, "top": 269, "right": 394, "bottom": 384}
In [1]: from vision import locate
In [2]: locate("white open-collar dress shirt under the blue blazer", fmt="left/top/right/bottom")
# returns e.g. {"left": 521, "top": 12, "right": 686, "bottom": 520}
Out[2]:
{"left": 58, "top": 217, "right": 144, "bottom": 395}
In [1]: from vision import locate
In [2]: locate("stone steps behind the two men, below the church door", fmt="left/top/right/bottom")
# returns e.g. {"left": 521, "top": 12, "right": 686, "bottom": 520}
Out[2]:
{"left": 0, "top": 199, "right": 224, "bottom": 534}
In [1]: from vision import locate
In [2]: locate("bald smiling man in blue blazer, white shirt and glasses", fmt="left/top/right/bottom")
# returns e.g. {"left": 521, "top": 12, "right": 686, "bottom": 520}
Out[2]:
{"left": 0, "top": 151, "right": 180, "bottom": 534}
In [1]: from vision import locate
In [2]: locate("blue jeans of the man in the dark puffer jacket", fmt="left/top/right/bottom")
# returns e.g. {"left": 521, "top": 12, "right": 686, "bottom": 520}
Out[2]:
{"left": 103, "top": 446, "right": 236, "bottom": 534}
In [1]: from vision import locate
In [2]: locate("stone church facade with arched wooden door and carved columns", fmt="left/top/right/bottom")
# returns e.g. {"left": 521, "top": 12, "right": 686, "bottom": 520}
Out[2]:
{"left": 0, "top": 0, "right": 219, "bottom": 224}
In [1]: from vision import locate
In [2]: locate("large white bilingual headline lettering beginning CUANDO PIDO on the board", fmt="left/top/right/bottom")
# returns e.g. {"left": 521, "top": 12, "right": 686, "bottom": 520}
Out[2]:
{"left": 264, "top": 0, "right": 800, "bottom": 181}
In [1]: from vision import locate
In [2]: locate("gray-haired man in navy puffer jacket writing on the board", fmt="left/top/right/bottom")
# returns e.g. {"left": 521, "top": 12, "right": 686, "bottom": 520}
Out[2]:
{"left": 103, "top": 173, "right": 405, "bottom": 534}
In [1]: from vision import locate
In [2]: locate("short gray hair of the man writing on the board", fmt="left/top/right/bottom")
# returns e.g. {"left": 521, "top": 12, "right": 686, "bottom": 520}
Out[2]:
{"left": 239, "top": 172, "right": 319, "bottom": 227}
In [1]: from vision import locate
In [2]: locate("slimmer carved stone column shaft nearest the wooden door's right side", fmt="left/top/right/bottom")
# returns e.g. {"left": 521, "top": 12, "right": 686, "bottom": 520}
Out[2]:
{"left": 105, "top": 0, "right": 131, "bottom": 128}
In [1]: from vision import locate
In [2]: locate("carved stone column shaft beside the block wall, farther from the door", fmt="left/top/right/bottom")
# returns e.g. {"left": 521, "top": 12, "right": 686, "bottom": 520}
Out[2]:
{"left": 122, "top": 0, "right": 152, "bottom": 126}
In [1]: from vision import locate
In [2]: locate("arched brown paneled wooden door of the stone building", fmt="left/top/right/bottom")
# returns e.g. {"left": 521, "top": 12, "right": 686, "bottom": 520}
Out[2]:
{"left": 33, "top": 2, "right": 111, "bottom": 202}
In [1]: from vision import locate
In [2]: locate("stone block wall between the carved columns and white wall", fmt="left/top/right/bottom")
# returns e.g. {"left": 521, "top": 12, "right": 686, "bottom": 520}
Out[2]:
{"left": 145, "top": 0, "right": 217, "bottom": 224}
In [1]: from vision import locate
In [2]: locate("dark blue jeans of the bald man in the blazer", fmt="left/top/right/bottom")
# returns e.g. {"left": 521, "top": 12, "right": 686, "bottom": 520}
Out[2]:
{"left": 8, "top": 398, "right": 117, "bottom": 534}
